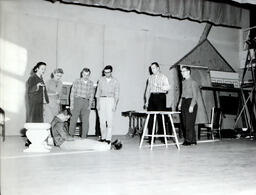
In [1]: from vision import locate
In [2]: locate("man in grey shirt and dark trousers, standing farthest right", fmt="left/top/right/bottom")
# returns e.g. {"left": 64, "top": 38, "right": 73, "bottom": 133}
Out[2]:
{"left": 178, "top": 66, "right": 199, "bottom": 146}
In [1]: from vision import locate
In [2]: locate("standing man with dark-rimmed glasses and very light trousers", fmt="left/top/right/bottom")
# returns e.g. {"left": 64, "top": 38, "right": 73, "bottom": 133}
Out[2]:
{"left": 96, "top": 65, "right": 120, "bottom": 144}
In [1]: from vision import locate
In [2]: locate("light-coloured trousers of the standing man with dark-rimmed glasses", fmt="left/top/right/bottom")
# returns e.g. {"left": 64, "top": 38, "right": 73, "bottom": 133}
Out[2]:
{"left": 98, "top": 97, "right": 114, "bottom": 140}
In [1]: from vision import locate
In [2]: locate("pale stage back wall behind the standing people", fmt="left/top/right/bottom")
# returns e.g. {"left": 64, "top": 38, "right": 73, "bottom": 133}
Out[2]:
{"left": 0, "top": 0, "right": 248, "bottom": 135}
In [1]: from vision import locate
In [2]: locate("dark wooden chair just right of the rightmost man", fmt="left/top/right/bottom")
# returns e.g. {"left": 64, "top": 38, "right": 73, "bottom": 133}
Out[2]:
{"left": 198, "top": 107, "right": 222, "bottom": 140}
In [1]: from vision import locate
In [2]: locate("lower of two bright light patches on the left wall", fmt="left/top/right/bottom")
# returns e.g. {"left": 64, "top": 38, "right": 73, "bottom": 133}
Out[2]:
{"left": 0, "top": 74, "right": 25, "bottom": 113}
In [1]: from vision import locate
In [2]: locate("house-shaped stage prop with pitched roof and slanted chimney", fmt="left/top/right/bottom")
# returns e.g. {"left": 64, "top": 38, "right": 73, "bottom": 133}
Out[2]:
{"left": 170, "top": 24, "right": 244, "bottom": 139}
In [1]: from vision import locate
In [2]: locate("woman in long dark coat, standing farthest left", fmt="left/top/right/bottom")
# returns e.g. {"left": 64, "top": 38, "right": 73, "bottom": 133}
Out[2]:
{"left": 27, "top": 62, "right": 49, "bottom": 123}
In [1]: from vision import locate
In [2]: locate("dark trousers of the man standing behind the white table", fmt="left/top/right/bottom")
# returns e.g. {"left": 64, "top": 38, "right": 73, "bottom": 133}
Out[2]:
{"left": 148, "top": 93, "right": 166, "bottom": 134}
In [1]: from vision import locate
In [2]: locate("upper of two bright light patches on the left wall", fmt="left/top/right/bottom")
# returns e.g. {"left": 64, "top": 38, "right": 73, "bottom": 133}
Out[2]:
{"left": 0, "top": 39, "right": 27, "bottom": 76}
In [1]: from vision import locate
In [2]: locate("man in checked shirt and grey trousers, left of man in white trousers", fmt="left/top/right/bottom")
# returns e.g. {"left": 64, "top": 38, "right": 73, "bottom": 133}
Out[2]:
{"left": 69, "top": 68, "right": 94, "bottom": 138}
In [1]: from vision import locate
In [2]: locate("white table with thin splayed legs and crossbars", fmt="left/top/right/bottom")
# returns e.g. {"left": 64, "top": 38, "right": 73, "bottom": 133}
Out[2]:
{"left": 137, "top": 111, "right": 180, "bottom": 150}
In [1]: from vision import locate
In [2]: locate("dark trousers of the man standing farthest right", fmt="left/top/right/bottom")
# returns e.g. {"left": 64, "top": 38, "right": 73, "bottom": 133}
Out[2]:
{"left": 181, "top": 98, "right": 197, "bottom": 143}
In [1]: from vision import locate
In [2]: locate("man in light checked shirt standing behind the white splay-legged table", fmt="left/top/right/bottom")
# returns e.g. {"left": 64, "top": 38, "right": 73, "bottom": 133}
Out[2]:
{"left": 145, "top": 62, "right": 170, "bottom": 142}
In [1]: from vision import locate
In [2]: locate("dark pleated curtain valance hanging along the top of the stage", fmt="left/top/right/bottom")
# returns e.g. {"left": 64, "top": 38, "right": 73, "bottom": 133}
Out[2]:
{"left": 50, "top": 0, "right": 246, "bottom": 28}
